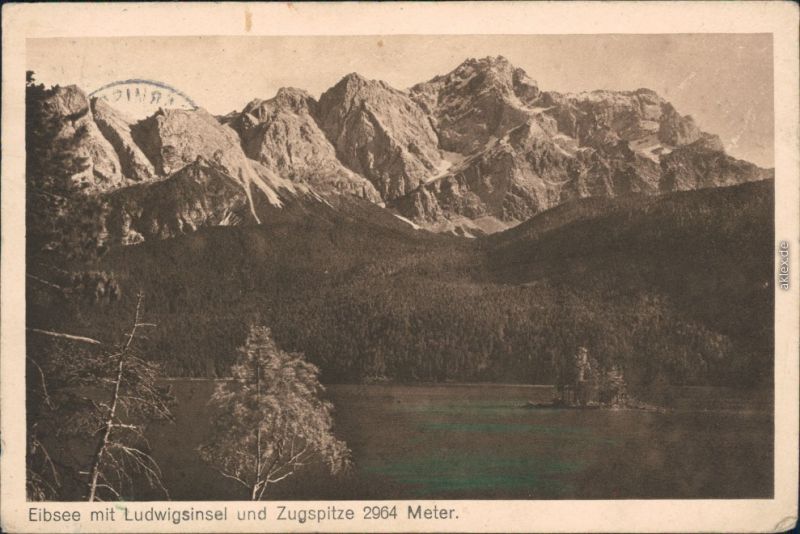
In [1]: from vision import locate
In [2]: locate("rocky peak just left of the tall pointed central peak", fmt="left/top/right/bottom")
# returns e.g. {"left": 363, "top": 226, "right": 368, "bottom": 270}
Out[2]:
{"left": 223, "top": 88, "right": 382, "bottom": 203}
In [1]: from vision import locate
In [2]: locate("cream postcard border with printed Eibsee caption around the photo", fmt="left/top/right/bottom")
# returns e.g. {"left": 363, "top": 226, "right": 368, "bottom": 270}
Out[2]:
{"left": 0, "top": 2, "right": 800, "bottom": 532}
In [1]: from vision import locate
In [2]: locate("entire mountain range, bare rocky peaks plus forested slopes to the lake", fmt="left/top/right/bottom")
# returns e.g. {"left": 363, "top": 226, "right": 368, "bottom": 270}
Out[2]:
{"left": 27, "top": 57, "right": 774, "bottom": 390}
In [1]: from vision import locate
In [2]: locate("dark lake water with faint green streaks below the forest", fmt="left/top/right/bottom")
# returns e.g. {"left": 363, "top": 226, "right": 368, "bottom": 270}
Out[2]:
{"left": 151, "top": 381, "right": 773, "bottom": 500}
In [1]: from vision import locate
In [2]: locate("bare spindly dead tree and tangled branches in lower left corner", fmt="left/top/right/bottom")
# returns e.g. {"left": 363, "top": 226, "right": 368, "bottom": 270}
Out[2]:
{"left": 28, "top": 294, "right": 172, "bottom": 501}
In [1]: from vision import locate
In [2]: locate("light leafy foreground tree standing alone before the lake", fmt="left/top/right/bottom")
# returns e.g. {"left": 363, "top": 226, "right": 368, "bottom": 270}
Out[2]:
{"left": 198, "top": 326, "right": 350, "bottom": 500}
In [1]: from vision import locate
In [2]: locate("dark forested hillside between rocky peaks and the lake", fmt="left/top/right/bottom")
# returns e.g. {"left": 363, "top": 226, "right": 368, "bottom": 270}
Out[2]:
{"left": 39, "top": 181, "right": 773, "bottom": 385}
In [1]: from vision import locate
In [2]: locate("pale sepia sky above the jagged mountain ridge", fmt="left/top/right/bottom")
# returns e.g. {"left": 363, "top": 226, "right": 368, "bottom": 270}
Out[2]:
{"left": 26, "top": 34, "right": 774, "bottom": 167}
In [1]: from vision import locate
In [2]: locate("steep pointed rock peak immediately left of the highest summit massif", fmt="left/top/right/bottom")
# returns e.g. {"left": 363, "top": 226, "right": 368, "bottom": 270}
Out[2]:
{"left": 318, "top": 74, "right": 442, "bottom": 200}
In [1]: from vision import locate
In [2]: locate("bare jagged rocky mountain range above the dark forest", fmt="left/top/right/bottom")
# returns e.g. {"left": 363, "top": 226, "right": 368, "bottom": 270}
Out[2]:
{"left": 42, "top": 56, "right": 774, "bottom": 244}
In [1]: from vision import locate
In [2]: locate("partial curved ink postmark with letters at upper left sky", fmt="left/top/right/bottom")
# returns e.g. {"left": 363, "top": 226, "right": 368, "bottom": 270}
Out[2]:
{"left": 89, "top": 79, "right": 197, "bottom": 119}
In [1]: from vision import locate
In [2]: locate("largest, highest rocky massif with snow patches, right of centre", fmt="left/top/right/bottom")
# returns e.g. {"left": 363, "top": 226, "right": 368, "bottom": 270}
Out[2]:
{"left": 391, "top": 57, "right": 771, "bottom": 235}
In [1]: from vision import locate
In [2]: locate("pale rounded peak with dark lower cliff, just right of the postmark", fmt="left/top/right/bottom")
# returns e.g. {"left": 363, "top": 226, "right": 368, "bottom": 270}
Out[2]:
{"left": 113, "top": 109, "right": 316, "bottom": 242}
